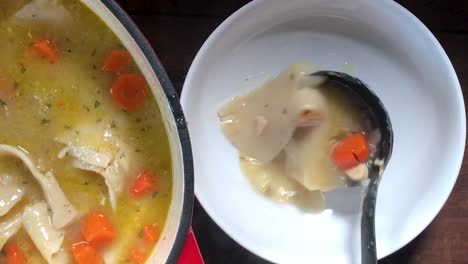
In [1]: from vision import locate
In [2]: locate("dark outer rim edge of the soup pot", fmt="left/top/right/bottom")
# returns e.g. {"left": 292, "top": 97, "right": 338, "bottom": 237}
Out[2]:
{"left": 101, "top": 0, "right": 194, "bottom": 263}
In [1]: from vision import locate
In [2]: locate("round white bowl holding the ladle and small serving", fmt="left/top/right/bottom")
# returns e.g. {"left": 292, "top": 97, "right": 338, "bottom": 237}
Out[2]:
{"left": 182, "top": 0, "right": 466, "bottom": 263}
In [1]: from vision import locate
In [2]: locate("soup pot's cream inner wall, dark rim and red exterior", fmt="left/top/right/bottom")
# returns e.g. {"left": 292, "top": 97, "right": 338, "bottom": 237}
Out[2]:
{"left": 81, "top": 0, "right": 203, "bottom": 264}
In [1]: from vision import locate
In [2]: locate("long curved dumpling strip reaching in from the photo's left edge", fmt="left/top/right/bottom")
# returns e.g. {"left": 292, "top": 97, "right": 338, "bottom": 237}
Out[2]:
{"left": 0, "top": 144, "right": 78, "bottom": 228}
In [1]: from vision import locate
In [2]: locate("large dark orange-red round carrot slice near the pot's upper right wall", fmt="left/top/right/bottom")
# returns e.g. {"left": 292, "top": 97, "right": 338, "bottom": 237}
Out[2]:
{"left": 111, "top": 74, "right": 149, "bottom": 111}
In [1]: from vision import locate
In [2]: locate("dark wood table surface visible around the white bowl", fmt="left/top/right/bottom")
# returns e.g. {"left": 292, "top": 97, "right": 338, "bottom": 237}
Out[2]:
{"left": 121, "top": 0, "right": 468, "bottom": 264}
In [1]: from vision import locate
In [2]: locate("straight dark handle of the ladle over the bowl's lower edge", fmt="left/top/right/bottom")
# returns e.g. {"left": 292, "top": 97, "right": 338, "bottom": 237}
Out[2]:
{"left": 361, "top": 166, "right": 379, "bottom": 264}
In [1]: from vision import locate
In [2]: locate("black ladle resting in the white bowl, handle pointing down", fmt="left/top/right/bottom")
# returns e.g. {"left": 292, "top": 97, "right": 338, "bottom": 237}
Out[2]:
{"left": 310, "top": 71, "right": 393, "bottom": 264}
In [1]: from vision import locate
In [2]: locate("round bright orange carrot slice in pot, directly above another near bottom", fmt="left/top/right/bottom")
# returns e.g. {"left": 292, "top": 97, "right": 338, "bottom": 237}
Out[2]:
{"left": 81, "top": 212, "right": 116, "bottom": 247}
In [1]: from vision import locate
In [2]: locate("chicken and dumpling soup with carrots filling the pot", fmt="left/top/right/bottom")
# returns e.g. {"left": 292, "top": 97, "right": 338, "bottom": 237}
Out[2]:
{"left": 0, "top": 0, "right": 172, "bottom": 264}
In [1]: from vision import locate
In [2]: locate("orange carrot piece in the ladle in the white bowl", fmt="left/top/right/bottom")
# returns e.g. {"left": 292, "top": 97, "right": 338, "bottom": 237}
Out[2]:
{"left": 332, "top": 133, "right": 369, "bottom": 170}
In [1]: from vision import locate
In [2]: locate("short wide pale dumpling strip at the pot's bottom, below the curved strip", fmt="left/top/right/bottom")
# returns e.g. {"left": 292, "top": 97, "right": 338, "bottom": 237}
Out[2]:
{"left": 23, "top": 201, "right": 65, "bottom": 263}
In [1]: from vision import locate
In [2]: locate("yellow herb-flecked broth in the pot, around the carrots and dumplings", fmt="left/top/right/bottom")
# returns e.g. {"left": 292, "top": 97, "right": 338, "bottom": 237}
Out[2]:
{"left": 0, "top": 0, "right": 172, "bottom": 263}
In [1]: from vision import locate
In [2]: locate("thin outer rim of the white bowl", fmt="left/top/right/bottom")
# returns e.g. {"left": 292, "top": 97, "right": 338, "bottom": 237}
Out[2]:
{"left": 181, "top": 0, "right": 466, "bottom": 261}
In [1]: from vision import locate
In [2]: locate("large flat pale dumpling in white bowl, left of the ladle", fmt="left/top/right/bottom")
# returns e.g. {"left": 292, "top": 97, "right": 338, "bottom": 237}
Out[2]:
{"left": 218, "top": 64, "right": 327, "bottom": 162}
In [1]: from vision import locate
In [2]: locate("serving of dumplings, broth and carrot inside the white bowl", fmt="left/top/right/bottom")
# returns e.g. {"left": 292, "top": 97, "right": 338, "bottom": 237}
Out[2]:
{"left": 218, "top": 64, "right": 377, "bottom": 210}
